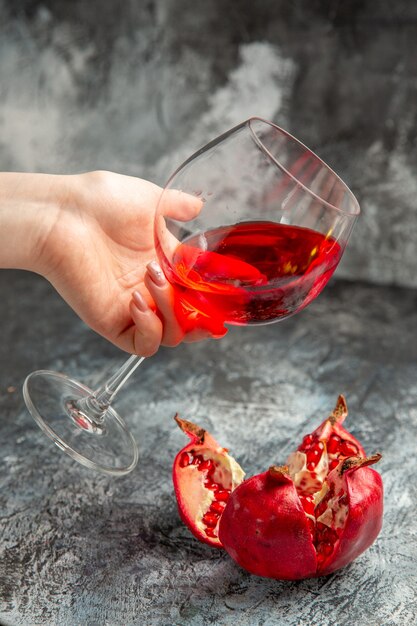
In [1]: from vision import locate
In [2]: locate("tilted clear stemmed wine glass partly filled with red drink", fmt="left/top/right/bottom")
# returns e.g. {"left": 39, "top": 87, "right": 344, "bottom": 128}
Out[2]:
{"left": 23, "top": 117, "right": 360, "bottom": 475}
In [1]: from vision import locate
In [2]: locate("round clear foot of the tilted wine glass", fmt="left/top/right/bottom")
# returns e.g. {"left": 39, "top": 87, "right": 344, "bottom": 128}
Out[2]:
{"left": 23, "top": 370, "right": 138, "bottom": 476}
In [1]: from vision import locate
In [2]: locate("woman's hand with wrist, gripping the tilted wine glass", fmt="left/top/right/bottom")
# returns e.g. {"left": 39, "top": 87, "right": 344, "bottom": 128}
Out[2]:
{"left": 0, "top": 172, "right": 224, "bottom": 356}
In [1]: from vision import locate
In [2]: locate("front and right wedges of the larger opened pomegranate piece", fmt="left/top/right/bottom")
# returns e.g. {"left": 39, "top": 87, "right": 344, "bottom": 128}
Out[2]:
{"left": 219, "top": 454, "right": 382, "bottom": 580}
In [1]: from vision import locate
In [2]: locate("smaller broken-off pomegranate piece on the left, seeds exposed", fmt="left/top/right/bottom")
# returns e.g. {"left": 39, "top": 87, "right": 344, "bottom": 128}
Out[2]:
{"left": 172, "top": 415, "right": 245, "bottom": 548}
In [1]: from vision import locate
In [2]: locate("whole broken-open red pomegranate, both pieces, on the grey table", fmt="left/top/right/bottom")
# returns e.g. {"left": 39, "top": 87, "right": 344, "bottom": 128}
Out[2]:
{"left": 174, "top": 396, "right": 383, "bottom": 580}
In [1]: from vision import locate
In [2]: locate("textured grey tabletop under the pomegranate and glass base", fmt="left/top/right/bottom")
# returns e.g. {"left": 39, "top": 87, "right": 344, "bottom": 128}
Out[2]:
{"left": 0, "top": 271, "right": 417, "bottom": 626}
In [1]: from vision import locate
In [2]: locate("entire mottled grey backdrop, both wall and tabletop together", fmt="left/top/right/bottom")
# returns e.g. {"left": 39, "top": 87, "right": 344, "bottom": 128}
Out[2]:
{"left": 0, "top": 0, "right": 417, "bottom": 626}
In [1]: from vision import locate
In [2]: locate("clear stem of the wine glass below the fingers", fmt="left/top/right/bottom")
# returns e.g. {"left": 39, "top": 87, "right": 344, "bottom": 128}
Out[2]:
{"left": 76, "top": 354, "right": 145, "bottom": 424}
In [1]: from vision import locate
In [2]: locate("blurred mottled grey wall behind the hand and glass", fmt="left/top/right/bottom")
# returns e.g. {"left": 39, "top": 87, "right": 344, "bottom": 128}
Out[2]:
{"left": 0, "top": 0, "right": 417, "bottom": 287}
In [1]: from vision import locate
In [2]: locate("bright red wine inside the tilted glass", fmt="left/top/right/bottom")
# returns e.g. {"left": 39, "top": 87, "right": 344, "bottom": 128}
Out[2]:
{"left": 163, "top": 221, "right": 341, "bottom": 334}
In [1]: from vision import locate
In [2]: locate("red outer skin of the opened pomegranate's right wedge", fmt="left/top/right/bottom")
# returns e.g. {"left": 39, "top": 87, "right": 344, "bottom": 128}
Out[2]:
{"left": 317, "top": 460, "right": 384, "bottom": 576}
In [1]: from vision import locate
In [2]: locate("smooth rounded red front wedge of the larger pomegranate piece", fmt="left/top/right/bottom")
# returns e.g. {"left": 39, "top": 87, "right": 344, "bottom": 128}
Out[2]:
{"left": 219, "top": 470, "right": 317, "bottom": 580}
